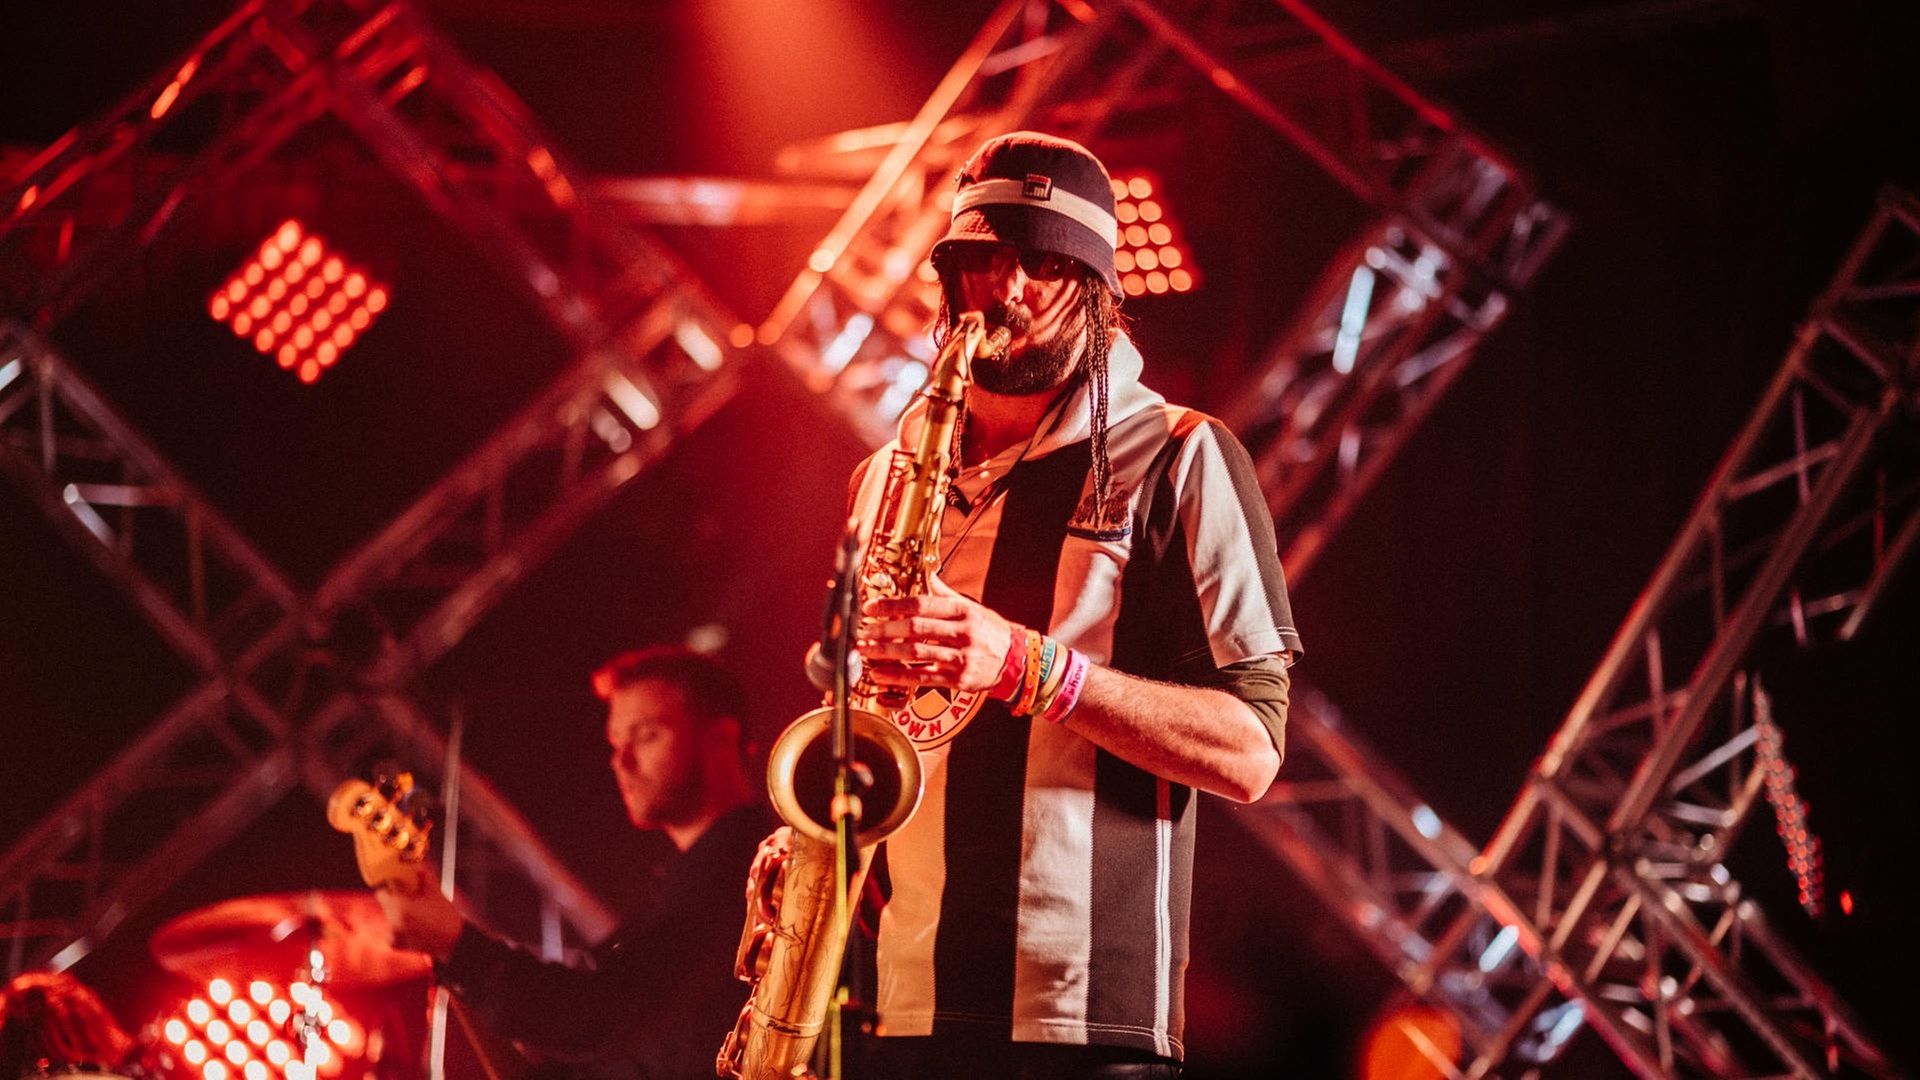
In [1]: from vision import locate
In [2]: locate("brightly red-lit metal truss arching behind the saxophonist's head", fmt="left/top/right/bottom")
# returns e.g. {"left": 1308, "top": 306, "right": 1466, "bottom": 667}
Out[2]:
{"left": 744, "top": 0, "right": 1567, "bottom": 577}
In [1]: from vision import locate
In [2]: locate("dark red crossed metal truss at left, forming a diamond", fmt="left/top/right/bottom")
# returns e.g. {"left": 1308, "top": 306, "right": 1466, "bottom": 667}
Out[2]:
{"left": 0, "top": 0, "right": 737, "bottom": 970}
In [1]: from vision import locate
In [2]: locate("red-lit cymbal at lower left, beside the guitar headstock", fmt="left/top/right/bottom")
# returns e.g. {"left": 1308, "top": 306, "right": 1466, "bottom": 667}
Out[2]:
{"left": 148, "top": 890, "right": 432, "bottom": 986}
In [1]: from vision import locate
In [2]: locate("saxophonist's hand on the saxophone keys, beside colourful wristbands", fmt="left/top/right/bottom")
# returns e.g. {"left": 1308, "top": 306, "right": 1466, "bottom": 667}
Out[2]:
{"left": 858, "top": 577, "right": 1014, "bottom": 690}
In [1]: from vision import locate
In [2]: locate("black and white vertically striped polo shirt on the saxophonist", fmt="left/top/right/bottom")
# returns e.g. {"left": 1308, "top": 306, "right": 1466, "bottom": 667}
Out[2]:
{"left": 854, "top": 334, "right": 1300, "bottom": 1057}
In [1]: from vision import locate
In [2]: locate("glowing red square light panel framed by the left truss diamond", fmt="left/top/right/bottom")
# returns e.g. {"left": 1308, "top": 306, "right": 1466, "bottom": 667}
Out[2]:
{"left": 207, "top": 219, "right": 388, "bottom": 382}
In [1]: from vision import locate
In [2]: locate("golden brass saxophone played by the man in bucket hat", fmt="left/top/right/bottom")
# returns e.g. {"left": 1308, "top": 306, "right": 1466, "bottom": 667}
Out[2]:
{"left": 714, "top": 311, "right": 1008, "bottom": 1080}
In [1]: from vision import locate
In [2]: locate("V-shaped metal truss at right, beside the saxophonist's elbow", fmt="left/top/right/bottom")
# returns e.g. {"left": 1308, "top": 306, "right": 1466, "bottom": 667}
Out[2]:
{"left": 1236, "top": 190, "right": 1920, "bottom": 1076}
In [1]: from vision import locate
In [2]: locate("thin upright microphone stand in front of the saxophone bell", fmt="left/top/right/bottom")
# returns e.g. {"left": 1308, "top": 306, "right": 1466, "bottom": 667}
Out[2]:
{"left": 820, "top": 521, "right": 874, "bottom": 1080}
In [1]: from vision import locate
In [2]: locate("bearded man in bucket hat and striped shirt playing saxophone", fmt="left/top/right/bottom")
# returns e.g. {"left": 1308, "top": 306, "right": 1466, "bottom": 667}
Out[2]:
{"left": 762, "top": 133, "right": 1302, "bottom": 1080}
